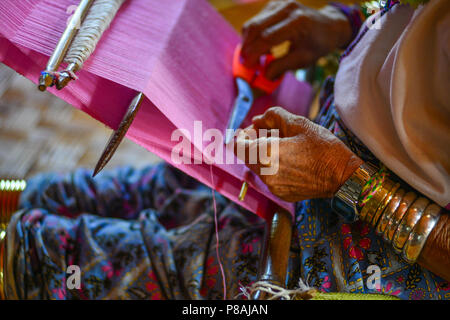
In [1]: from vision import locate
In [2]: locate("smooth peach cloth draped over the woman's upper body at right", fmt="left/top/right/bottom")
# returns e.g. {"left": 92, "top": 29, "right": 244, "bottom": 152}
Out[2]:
{"left": 335, "top": 0, "right": 450, "bottom": 206}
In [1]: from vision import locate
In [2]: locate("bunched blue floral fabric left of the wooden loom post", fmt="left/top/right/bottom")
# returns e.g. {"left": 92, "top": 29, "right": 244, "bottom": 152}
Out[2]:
{"left": 5, "top": 164, "right": 264, "bottom": 299}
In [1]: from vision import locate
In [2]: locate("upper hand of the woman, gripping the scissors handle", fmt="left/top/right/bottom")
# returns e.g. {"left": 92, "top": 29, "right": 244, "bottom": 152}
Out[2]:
{"left": 242, "top": 0, "right": 352, "bottom": 79}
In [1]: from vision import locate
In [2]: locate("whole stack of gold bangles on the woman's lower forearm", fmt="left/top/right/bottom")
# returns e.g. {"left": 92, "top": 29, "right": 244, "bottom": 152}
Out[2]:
{"left": 359, "top": 166, "right": 442, "bottom": 263}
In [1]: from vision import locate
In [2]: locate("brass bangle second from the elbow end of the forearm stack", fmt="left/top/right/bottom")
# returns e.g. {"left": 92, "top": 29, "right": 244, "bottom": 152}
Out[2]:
{"left": 392, "top": 197, "right": 430, "bottom": 253}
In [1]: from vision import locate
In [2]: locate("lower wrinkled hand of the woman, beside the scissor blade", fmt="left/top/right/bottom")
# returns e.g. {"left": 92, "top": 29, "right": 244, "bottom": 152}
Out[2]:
{"left": 235, "top": 107, "right": 363, "bottom": 202}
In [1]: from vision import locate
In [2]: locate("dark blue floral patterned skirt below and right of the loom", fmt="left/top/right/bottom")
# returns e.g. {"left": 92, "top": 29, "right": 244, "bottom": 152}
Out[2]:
{"left": 5, "top": 80, "right": 450, "bottom": 299}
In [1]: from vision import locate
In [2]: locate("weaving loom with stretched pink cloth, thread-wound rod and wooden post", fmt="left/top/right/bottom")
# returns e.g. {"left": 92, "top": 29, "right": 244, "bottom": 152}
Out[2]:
{"left": 0, "top": 0, "right": 311, "bottom": 299}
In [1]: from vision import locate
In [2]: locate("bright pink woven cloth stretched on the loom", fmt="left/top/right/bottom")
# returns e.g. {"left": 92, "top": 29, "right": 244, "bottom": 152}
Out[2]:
{"left": 0, "top": 0, "right": 311, "bottom": 218}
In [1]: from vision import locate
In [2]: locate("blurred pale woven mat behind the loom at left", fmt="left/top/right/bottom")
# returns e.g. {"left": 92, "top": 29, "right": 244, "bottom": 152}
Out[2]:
{"left": 0, "top": 64, "right": 160, "bottom": 179}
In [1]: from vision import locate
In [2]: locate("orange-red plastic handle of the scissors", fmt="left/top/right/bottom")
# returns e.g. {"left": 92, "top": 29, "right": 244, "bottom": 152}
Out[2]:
{"left": 233, "top": 44, "right": 283, "bottom": 94}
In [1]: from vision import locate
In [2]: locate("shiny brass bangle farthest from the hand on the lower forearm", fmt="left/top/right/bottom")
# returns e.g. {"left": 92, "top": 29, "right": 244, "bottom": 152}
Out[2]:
{"left": 402, "top": 203, "right": 442, "bottom": 263}
